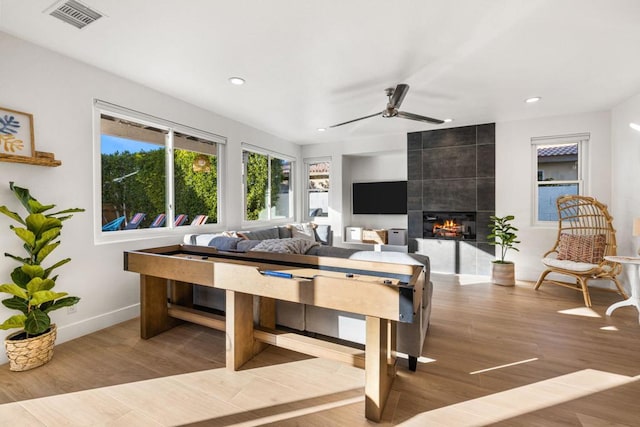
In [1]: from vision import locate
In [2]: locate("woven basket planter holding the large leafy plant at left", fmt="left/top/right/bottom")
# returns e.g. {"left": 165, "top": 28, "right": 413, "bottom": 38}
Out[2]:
{"left": 4, "top": 324, "right": 57, "bottom": 371}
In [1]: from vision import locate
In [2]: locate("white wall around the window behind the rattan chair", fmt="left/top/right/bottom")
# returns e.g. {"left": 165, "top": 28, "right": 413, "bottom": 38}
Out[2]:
{"left": 496, "top": 112, "right": 615, "bottom": 280}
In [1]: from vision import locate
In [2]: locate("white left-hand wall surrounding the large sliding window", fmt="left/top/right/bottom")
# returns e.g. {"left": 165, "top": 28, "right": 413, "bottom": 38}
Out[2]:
{"left": 0, "top": 32, "right": 300, "bottom": 363}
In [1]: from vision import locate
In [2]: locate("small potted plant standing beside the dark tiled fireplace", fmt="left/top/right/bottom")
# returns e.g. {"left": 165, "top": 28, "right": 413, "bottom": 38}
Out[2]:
{"left": 487, "top": 215, "right": 520, "bottom": 286}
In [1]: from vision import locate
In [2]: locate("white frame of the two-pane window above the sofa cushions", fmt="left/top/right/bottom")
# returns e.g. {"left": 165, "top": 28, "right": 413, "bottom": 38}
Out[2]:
{"left": 240, "top": 142, "right": 297, "bottom": 227}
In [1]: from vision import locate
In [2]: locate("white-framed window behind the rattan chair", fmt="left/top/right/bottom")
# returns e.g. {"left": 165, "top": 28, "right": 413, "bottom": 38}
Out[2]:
{"left": 531, "top": 134, "right": 589, "bottom": 223}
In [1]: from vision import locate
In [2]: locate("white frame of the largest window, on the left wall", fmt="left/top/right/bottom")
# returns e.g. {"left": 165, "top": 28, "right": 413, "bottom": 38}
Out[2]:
{"left": 93, "top": 99, "right": 227, "bottom": 244}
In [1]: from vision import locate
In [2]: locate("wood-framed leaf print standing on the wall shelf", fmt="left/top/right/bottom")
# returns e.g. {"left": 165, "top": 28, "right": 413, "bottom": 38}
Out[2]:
{"left": 0, "top": 107, "right": 36, "bottom": 158}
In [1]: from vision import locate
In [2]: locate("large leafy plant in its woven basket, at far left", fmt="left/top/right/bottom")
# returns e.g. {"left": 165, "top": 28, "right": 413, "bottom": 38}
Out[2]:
{"left": 0, "top": 182, "right": 84, "bottom": 371}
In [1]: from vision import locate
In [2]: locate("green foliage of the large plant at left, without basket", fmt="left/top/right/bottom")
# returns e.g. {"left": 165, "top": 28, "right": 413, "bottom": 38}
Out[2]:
{"left": 0, "top": 182, "right": 84, "bottom": 338}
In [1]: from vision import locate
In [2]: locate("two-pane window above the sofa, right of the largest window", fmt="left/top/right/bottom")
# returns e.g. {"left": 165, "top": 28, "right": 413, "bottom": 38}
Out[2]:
{"left": 242, "top": 148, "right": 293, "bottom": 221}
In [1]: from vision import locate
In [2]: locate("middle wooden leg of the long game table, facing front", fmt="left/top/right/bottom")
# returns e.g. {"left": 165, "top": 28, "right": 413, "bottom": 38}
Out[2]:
{"left": 225, "top": 290, "right": 254, "bottom": 371}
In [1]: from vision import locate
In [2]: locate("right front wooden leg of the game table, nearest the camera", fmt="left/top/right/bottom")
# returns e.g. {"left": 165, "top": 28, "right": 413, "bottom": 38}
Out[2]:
{"left": 364, "top": 316, "right": 396, "bottom": 422}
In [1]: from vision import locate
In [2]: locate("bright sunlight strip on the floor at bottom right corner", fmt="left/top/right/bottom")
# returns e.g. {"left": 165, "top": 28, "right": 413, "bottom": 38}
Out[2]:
{"left": 398, "top": 369, "right": 638, "bottom": 427}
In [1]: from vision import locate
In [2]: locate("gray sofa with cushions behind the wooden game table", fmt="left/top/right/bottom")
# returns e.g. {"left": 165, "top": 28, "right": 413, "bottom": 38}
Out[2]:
{"left": 184, "top": 227, "right": 433, "bottom": 371}
